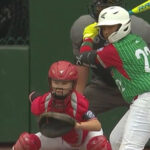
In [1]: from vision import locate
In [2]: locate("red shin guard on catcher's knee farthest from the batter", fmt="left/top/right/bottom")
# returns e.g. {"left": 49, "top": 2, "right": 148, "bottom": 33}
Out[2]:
{"left": 12, "top": 132, "right": 41, "bottom": 150}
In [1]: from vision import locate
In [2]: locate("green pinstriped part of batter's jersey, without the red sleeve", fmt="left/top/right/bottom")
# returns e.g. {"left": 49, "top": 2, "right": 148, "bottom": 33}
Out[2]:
{"left": 112, "top": 34, "right": 150, "bottom": 102}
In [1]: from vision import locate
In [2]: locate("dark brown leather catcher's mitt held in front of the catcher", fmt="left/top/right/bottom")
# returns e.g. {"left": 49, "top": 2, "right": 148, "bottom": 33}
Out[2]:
{"left": 39, "top": 112, "right": 76, "bottom": 138}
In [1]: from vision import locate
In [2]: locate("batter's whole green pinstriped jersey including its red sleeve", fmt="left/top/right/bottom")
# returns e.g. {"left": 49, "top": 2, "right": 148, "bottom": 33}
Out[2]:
{"left": 98, "top": 34, "right": 150, "bottom": 102}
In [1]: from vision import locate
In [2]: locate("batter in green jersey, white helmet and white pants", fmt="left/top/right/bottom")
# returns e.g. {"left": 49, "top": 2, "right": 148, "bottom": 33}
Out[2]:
{"left": 77, "top": 6, "right": 150, "bottom": 150}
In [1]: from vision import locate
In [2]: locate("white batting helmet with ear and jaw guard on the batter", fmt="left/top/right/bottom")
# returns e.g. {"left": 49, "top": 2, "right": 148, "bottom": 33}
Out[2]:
{"left": 97, "top": 6, "right": 131, "bottom": 43}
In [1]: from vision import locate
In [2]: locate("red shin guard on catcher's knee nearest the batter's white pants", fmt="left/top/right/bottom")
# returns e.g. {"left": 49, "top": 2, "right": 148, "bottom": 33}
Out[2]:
{"left": 87, "top": 135, "right": 112, "bottom": 150}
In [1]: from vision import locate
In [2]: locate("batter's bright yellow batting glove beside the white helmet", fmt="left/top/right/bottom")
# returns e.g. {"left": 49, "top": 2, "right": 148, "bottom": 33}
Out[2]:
{"left": 83, "top": 22, "right": 99, "bottom": 40}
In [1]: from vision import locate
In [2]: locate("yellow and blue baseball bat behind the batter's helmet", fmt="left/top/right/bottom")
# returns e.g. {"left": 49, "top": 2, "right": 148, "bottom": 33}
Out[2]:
{"left": 129, "top": 0, "right": 150, "bottom": 15}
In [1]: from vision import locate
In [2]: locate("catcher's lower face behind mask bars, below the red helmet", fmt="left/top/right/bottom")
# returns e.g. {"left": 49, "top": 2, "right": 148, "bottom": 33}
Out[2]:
{"left": 51, "top": 79, "right": 73, "bottom": 99}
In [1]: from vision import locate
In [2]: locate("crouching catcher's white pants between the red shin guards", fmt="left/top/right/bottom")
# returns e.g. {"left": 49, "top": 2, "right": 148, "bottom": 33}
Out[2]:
{"left": 36, "top": 130, "right": 103, "bottom": 150}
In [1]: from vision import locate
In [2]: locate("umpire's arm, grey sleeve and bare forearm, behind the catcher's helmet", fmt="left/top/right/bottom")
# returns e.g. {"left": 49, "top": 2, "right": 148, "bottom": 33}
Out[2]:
{"left": 70, "top": 15, "right": 94, "bottom": 93}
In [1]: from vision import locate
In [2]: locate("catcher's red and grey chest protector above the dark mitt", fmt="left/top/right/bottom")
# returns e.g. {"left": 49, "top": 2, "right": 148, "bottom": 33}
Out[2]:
{"left": 45, "top": 92, "right": 88, "bottom": 121}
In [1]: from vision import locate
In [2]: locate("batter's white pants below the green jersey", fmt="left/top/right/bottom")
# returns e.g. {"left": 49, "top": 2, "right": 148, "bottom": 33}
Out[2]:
{"left": 110, "top": 92, "right": 150, "bottom": 150}
